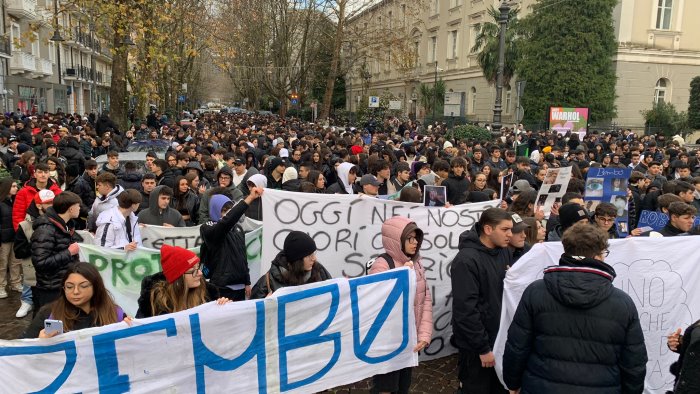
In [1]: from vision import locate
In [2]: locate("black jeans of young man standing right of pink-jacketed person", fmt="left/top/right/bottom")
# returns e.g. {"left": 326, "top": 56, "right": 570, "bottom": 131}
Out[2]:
{"left": 458, "top": 350, "right": 508, "bottom": 394}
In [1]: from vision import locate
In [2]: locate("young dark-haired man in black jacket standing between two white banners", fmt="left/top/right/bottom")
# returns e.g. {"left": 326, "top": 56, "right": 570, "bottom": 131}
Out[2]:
{"left": 450, "top": 208, "right": 513, "bottom": 394}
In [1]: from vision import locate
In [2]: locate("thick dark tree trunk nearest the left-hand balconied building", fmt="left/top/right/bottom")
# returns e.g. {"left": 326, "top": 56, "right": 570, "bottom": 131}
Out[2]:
{"left": 109, "top": 34, "right": 129, "bottom": 133}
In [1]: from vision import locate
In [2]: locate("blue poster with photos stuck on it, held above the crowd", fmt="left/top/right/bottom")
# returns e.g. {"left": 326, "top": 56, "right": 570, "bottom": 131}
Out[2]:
{"left": 583, "top": 168, "right": 639, "bottom": 238}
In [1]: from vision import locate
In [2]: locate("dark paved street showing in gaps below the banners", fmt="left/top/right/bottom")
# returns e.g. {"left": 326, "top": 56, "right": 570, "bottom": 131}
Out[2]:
{"left": 0, "top": 291, "right": 457, "bottom": 394}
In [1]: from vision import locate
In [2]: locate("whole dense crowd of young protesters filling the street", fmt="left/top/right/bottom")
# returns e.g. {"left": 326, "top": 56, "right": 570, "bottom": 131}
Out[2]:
{"left": 0, "top": 108, "right": 700, "bottom": 393}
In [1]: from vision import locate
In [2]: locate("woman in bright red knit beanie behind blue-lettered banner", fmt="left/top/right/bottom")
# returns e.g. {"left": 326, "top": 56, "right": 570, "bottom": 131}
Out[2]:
{"left": 136, "top": 245, "right": 229, "bottom": 318}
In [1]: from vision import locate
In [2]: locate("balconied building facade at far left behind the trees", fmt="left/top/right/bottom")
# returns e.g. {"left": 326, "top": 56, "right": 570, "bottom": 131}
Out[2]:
{"left": 0, "top": 0, "right": 111, "bottom": 114}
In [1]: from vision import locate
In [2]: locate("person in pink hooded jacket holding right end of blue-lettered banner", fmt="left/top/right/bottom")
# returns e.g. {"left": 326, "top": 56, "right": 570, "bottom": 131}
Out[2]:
{"left": 369, "top": 216, "right": 433, "bottom": 394}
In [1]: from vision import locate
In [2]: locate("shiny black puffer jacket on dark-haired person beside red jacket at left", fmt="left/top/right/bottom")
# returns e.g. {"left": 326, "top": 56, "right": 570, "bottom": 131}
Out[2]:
{"left": 31, "top": 207, "right": 83, "bottom": 290}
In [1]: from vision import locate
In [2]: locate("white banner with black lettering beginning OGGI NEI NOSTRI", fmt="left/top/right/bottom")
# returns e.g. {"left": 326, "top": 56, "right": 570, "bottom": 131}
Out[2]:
{"left": 260, "top": 189, "right": 500, "bottom": 359}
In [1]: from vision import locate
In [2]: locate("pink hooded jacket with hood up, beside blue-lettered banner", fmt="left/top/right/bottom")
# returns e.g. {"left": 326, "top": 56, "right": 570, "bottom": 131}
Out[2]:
{"left": 369, "top": 216, "right": 433, "bottom": 343}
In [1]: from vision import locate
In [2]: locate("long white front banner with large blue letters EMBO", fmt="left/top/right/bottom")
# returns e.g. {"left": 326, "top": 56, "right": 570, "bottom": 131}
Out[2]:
{"left": 0, "top": 268, "right": 418, "bottom": 393}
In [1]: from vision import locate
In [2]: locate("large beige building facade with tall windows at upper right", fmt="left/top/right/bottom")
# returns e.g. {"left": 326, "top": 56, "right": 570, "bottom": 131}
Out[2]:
{"left": 346, "top": 0, "right": 700, "bottom": 128}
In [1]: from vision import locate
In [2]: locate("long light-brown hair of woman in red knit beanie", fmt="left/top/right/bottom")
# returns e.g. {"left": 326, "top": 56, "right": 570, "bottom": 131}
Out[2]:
{"left": 151, "top": 275, "right": 207, "bottom": 316}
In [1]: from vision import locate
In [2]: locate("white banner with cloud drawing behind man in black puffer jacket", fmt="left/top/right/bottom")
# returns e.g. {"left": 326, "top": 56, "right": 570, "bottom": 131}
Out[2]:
{"left": 494, "top": 237, "right": 700, "bottom": 394}
